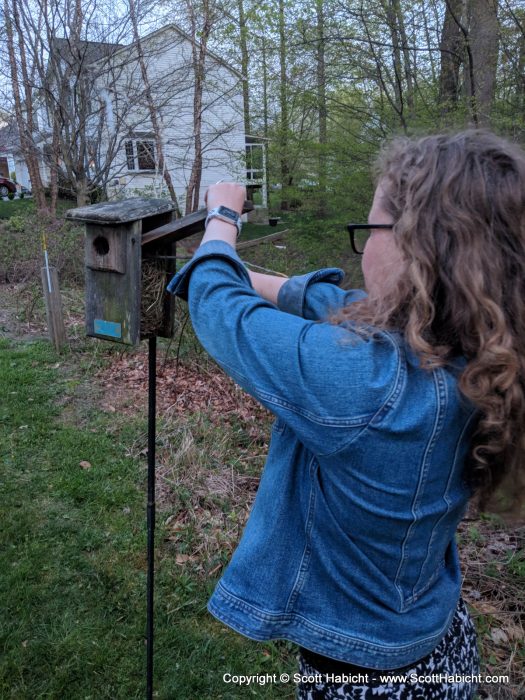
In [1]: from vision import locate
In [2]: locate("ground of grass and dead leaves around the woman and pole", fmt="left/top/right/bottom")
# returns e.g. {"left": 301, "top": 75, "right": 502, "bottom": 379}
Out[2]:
{"left": 0, "top": 202, "right": 525, "bottom": 700}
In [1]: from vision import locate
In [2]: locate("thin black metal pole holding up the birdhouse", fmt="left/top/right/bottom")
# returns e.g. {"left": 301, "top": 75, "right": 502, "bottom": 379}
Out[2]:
{"left": 146, "top": 336, "right": 157, "bottom": 700}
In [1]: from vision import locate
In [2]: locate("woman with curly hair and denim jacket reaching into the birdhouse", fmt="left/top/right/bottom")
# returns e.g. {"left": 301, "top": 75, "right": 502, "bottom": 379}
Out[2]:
{"left": 170, "top": 131, "right": 525, "bottom": 699}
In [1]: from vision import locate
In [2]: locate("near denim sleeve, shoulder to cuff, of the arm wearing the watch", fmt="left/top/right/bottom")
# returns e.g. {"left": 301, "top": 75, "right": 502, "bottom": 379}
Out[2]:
{"left": 169, "top": 241, "right": 399, "bottom": 455}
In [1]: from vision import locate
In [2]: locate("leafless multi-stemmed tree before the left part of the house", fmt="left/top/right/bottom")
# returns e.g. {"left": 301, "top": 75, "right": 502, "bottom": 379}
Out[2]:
{"left": 4, "top": 0, "right": 146, "bottom": 208}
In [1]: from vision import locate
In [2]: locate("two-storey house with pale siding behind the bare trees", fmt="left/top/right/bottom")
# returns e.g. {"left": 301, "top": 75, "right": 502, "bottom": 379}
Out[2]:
{"left": 29, "top": 24, "right": 267, "bottom": 215}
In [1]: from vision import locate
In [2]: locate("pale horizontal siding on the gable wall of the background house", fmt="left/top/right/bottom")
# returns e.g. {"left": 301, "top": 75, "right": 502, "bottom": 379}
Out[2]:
{"left": 101, "top": 28, "right": 245, "bottom": 209}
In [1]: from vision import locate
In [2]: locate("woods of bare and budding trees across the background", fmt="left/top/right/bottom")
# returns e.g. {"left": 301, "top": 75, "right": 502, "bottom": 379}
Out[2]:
{"left": 2, "top": 0, "right": 525, "bottom": 216}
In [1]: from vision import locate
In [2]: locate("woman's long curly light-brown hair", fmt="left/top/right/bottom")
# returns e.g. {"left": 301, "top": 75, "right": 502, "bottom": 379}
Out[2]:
{"left": 330, "top": 130, "right": 525, "bottom": 507}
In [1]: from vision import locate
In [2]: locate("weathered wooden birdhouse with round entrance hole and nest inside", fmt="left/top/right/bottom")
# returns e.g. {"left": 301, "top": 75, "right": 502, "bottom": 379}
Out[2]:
{"left": 66, "top": 198, "right": 175, "bottom": 345}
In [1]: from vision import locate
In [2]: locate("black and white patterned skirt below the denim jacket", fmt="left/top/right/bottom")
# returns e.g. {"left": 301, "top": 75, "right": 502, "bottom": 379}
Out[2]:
{"left": 296, "top": 598, "right": 479, "bottom": 700}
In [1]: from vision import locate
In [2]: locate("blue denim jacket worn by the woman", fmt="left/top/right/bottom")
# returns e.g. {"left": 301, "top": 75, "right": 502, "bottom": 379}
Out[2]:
{"left": 169, "top": 241, "right": 475, "bottom": 669}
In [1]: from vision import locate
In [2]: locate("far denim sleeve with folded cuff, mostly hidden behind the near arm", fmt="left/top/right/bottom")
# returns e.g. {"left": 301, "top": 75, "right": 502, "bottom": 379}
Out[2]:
{"left": 277, "top": 267, "right": 366, "bottom": 321}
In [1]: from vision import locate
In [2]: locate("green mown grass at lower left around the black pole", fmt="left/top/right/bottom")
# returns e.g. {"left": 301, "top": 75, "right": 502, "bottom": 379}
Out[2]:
{"left": 0, "top": 339, "right": 294, "bottom": 700}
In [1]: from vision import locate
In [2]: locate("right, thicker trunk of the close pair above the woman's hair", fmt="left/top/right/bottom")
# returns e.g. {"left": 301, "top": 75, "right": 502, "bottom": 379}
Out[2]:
{"left": 469, "top": 0, "right": 499, "bottom": 127}
